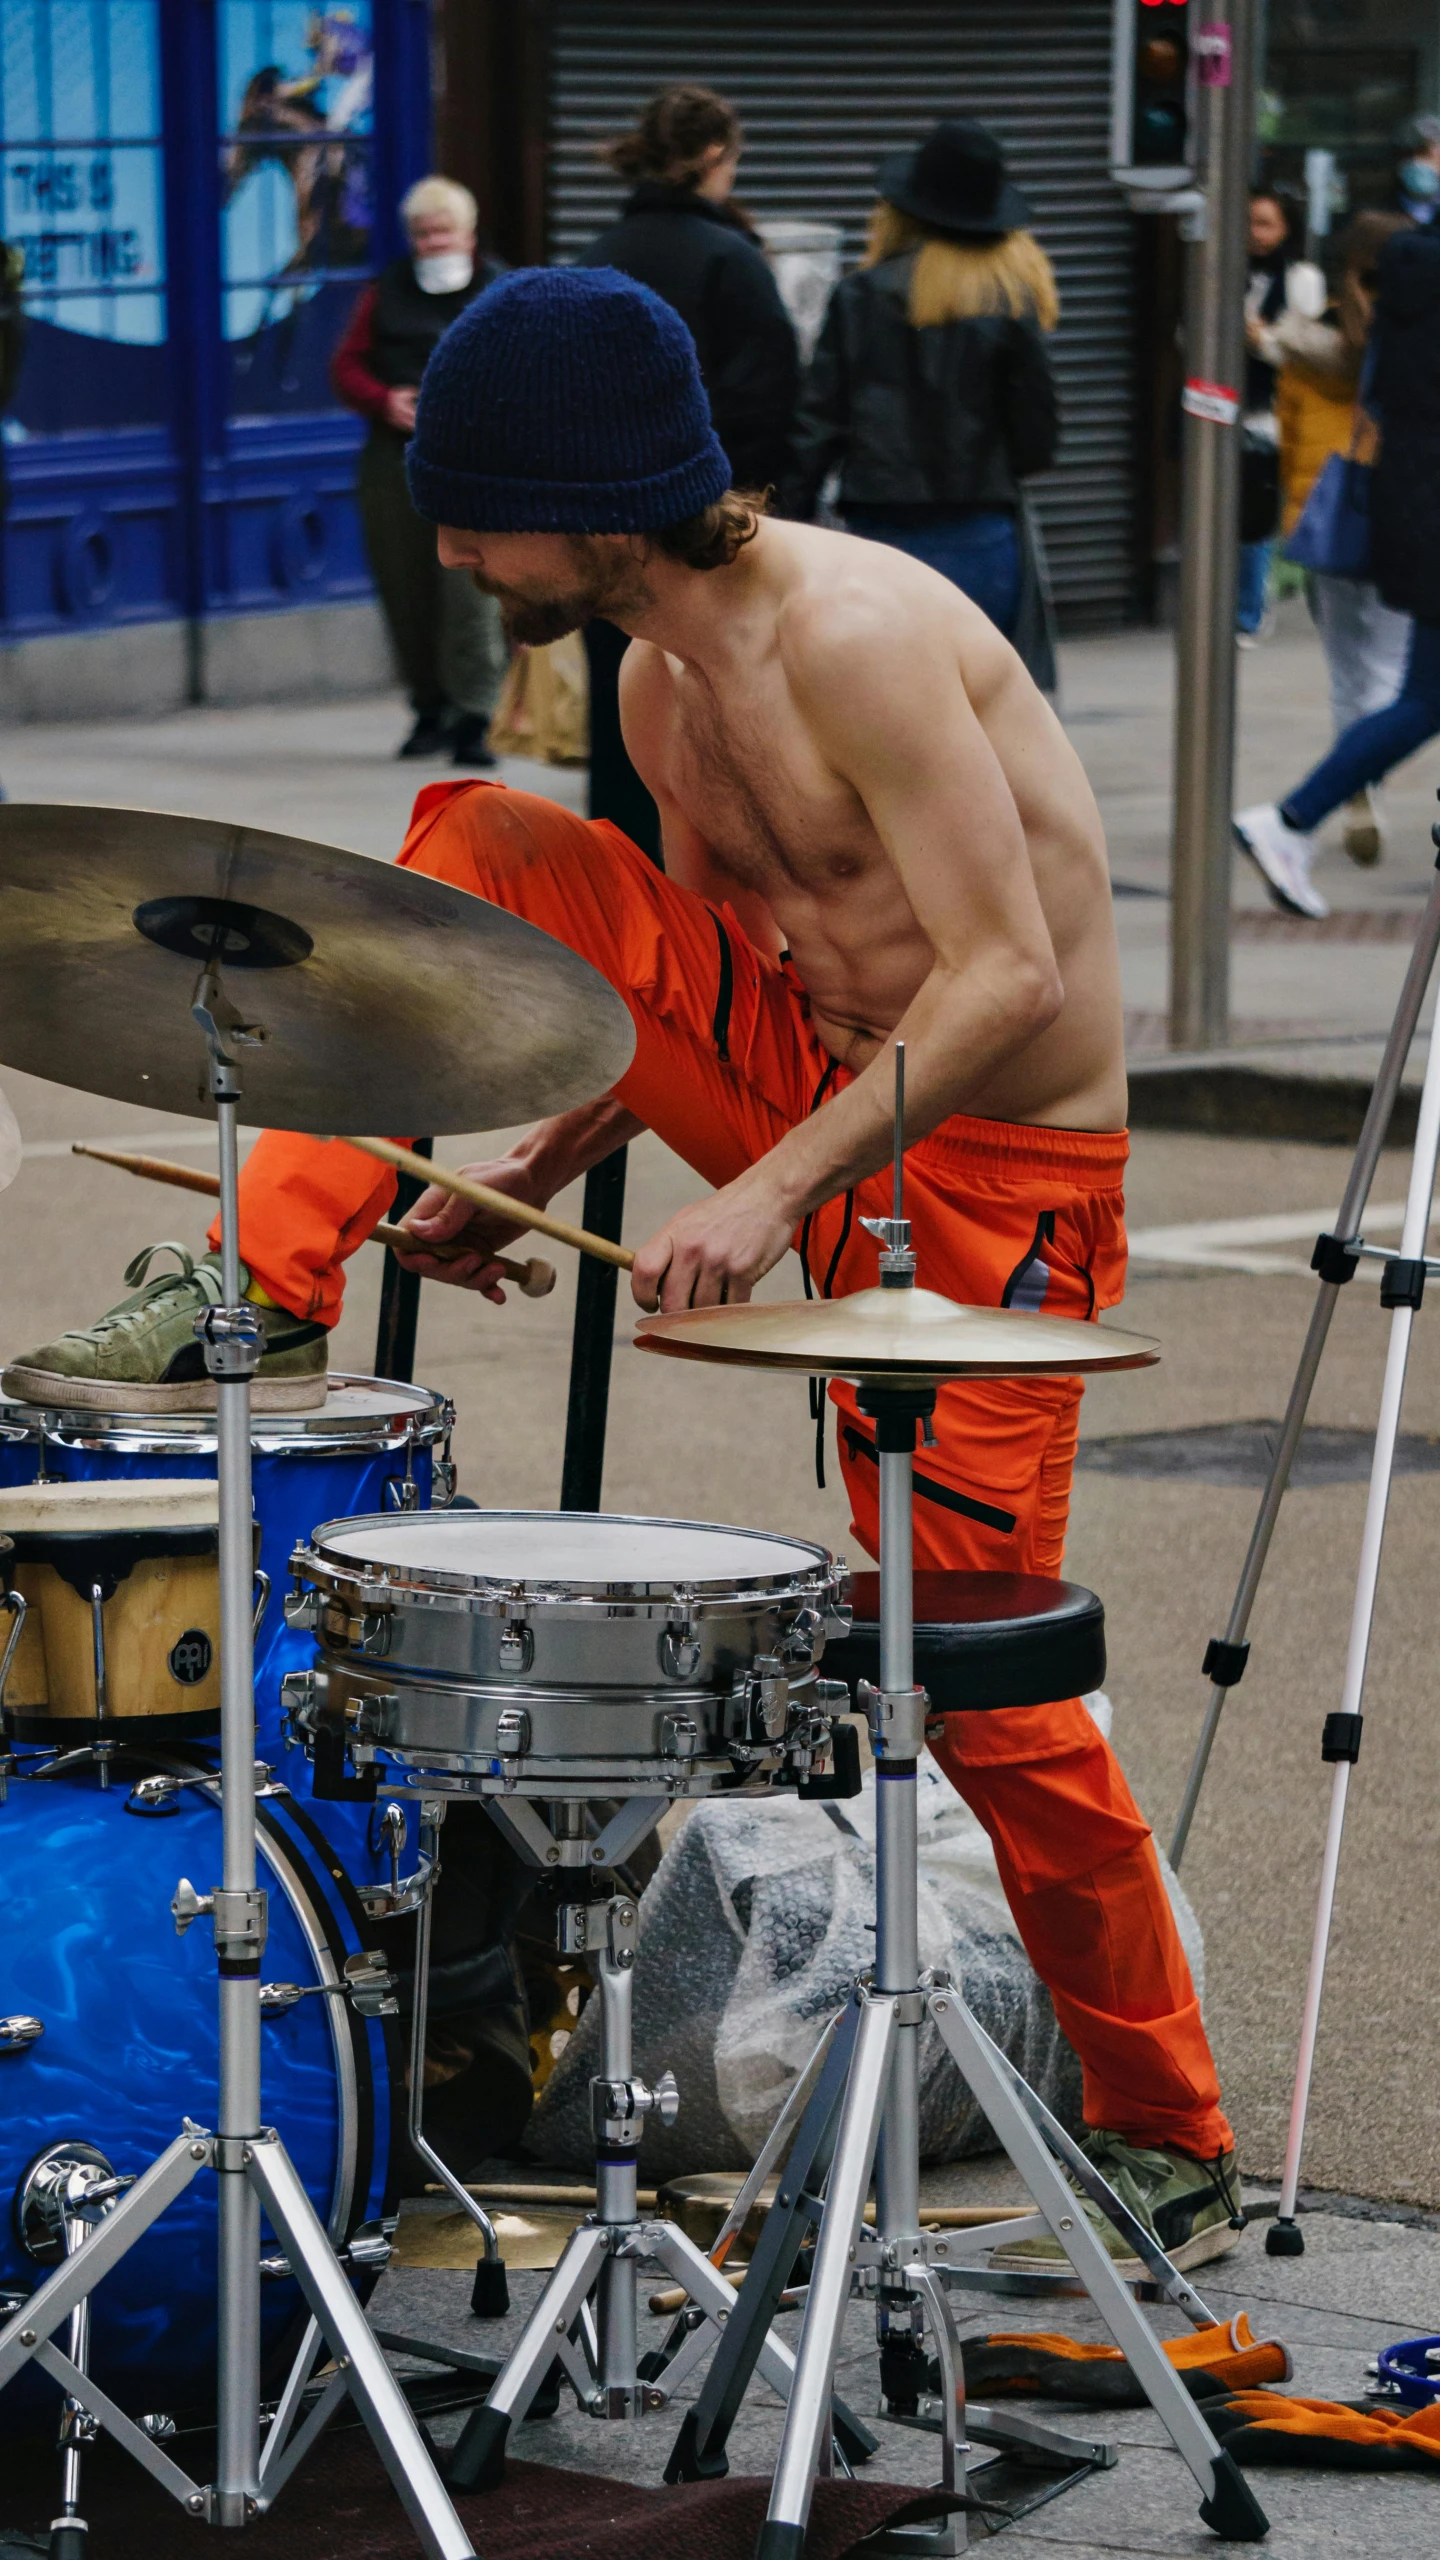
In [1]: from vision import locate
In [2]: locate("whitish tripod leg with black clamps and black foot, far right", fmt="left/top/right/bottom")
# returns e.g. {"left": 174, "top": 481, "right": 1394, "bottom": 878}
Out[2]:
{"left": 1266, "top": 957, "right": 1440, "bottom": 2258}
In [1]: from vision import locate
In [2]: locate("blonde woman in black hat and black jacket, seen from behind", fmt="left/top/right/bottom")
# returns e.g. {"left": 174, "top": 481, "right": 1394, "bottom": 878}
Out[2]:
{"left": 784, "top": 120, "right": 1061, "bottom": 689}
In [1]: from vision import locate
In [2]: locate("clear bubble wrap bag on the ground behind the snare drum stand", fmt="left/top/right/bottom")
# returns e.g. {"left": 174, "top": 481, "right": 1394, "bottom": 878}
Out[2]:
{"left": 525, "top": 1697, "right": 1202, "bottom": 2186}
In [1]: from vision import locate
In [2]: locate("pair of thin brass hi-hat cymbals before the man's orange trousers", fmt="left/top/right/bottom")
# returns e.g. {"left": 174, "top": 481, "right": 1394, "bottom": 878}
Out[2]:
{"left": 635, "top": 1288, "right": 1161, "bottom": 1377}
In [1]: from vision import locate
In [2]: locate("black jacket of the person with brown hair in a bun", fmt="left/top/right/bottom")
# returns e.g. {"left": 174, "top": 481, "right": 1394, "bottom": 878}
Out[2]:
{"left": 579, "top": 179, "right": 799, "bottom": 489}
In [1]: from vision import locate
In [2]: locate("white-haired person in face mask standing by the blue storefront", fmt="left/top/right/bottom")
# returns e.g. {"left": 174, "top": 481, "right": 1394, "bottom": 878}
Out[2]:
{"left": 331, "top": 177, "right": 507, "bottom": 765}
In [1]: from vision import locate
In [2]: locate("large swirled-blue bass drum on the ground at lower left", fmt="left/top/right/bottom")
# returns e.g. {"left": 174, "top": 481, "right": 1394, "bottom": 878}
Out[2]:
{"left": 0, "top": 1751, "right": 392, "bottom": 2437}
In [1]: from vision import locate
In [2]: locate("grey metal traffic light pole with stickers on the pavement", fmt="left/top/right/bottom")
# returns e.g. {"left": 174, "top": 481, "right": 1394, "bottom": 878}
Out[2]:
{"left": 1171, "top": 0, "right": 1258, "bottom": 1050}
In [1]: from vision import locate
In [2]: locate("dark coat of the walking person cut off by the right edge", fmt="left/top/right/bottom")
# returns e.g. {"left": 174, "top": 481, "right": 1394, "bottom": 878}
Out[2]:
{"left": 1366, "top": 230, "right": 1440, "bottom": 622}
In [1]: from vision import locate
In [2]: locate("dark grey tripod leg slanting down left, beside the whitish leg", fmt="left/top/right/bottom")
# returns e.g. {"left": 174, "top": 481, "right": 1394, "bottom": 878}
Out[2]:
{"left": 1171, "top": 827, "right": 1440, "bottom": 1869}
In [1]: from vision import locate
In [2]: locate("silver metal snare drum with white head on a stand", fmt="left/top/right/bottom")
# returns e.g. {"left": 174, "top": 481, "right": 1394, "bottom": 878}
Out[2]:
{"left": 287, "top": 1510, "right": 848, "bottom": 1797}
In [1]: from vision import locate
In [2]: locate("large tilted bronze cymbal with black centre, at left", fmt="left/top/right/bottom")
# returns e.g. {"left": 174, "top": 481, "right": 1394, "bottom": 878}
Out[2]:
{"left": 0, "top": 801, "right": 635, "bottom": 1134}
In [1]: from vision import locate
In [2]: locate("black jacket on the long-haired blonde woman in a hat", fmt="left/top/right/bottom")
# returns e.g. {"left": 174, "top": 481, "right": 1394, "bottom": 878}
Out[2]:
{"left": 784, "top": 251, "right": 1058, "bottom": 515}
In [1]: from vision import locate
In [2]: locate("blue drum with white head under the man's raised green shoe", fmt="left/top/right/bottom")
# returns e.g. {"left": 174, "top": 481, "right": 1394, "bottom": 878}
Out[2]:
{"left": 0, "top": 1370, "right": 454, "bottom": 1882}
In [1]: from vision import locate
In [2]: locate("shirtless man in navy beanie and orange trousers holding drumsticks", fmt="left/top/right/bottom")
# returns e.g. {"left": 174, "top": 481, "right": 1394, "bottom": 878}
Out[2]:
{"left": 5, "top": 269, "right": 1232, "bottom": 2263}
